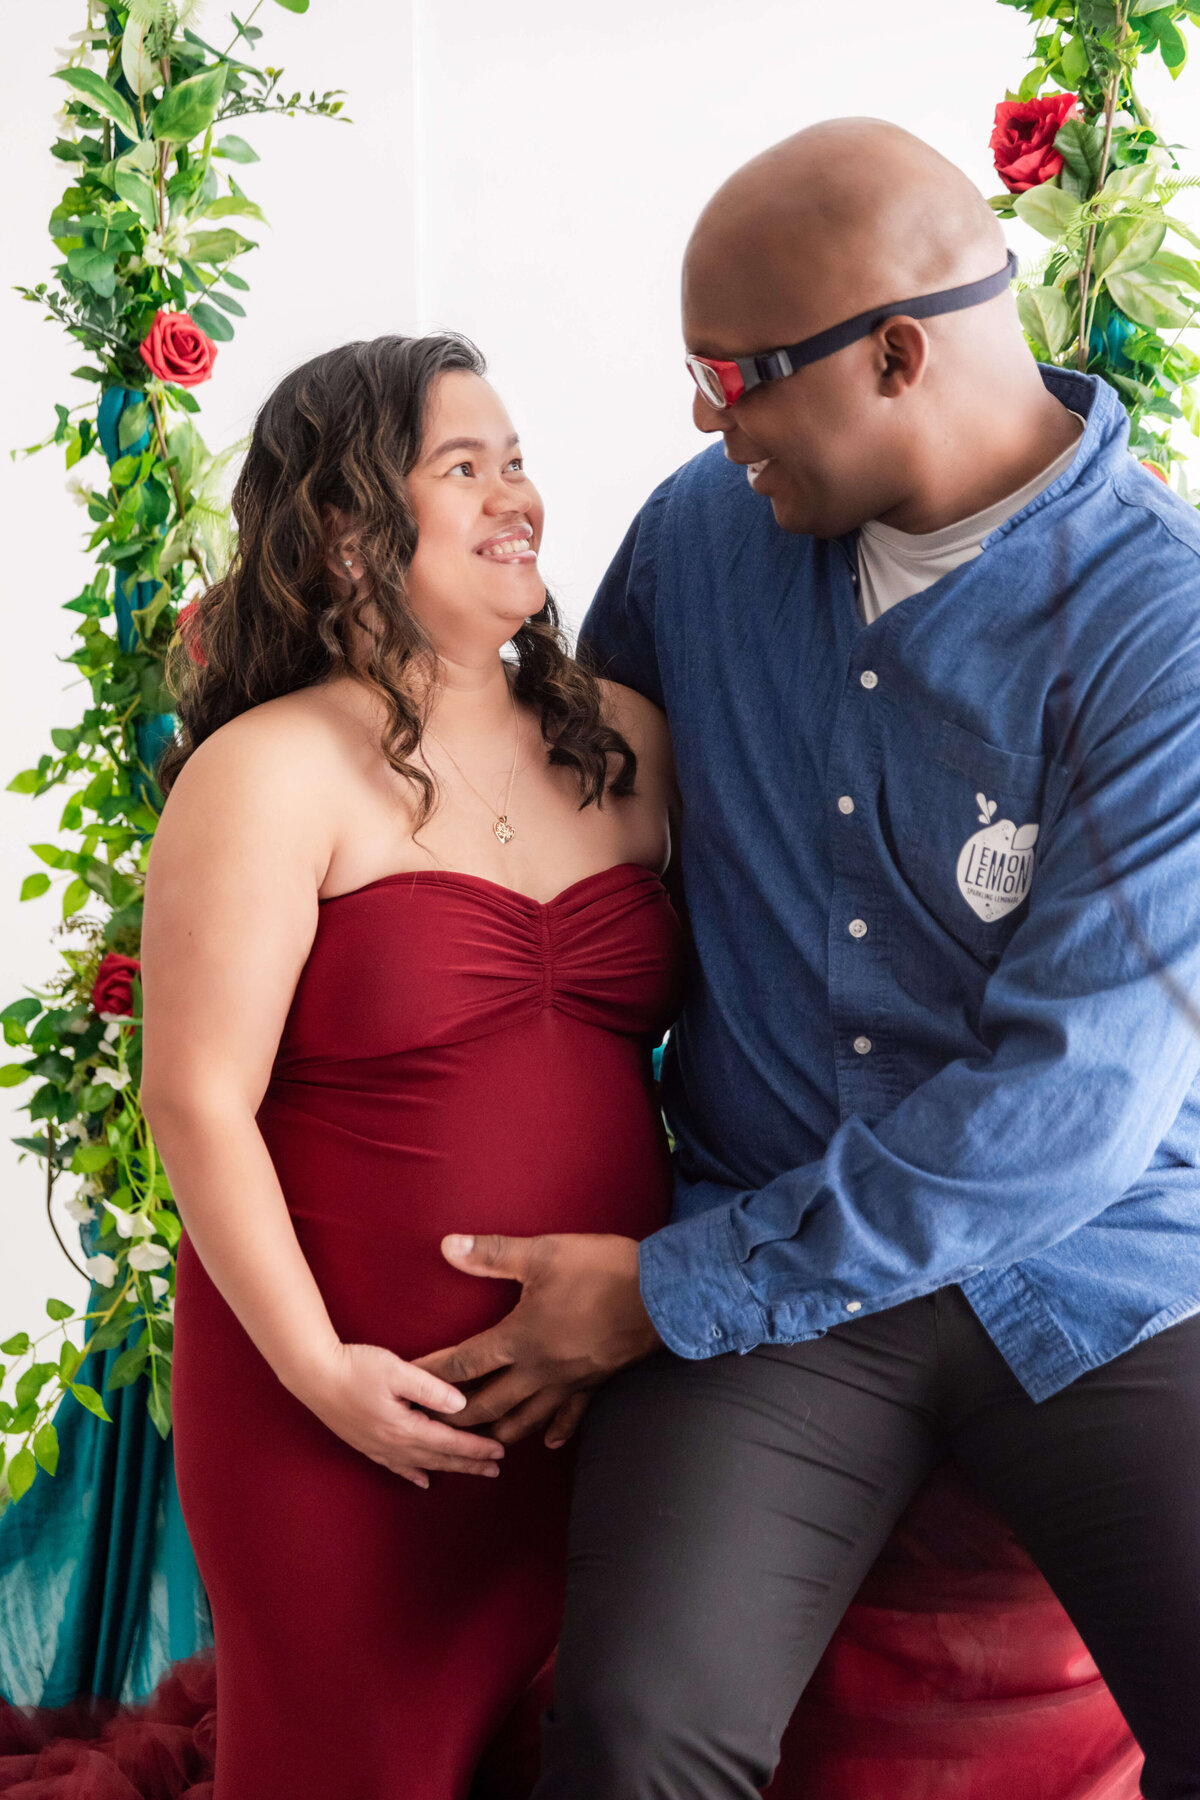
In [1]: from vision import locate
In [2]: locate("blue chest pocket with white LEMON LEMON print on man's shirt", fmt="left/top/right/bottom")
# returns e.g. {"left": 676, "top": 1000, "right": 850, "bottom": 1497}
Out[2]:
{"left": 896, "top": 720, "right": 1069, "bottom": 967}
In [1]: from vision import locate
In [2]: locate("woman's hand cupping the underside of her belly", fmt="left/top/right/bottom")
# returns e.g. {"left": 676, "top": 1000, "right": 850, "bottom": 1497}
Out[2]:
{"left": 290, "top": 1345, "right": 504, "bottom": 1487}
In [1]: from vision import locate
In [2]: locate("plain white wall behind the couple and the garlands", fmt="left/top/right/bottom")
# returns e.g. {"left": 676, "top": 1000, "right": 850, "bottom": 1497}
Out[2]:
{"left": 0, "top": 0, "right": 1200, "bottom": 1336}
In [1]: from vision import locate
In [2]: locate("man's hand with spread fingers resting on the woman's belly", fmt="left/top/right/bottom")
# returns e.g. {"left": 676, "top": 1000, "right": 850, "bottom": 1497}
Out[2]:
{"left": 416, "top": 1233, "right": 662, "bottom": 1445}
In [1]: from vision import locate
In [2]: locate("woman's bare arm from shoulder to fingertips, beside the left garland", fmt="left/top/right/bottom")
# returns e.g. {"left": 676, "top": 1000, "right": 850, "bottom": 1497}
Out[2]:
{"left": 142, "top": 702, "right": 498, "bottom": 1487}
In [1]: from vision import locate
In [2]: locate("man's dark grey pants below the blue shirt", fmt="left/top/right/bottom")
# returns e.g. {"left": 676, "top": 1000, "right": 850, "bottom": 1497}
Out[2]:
{"left": 534, "top": 1287, "right": 1200, "bottom": 1800}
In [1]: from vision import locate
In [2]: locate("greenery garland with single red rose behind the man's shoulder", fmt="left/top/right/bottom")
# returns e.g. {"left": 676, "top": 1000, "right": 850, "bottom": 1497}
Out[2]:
{"left": 991, "top": 0, "right": 1200, "bottom": 482}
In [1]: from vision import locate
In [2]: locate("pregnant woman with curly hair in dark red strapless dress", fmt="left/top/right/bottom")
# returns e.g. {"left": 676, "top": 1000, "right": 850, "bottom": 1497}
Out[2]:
{"left": 142, "top": 335, "right": 680, "bottom": 1800}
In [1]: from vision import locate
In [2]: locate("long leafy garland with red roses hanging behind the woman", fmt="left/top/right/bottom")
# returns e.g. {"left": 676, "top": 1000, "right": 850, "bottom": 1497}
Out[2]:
{"left": 0, "top": 0, "right": 342, "bottom": 1503}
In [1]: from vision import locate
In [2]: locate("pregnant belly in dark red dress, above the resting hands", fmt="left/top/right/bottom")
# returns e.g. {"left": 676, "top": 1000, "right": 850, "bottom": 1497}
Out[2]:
{"left": 250, "top": 1013, "right": 671, "bottom": 1357}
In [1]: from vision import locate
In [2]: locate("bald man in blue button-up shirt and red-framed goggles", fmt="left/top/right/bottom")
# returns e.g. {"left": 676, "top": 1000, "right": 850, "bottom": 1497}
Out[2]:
{"left": 434, "top": 119, "right": 1200, "bottom": 1800}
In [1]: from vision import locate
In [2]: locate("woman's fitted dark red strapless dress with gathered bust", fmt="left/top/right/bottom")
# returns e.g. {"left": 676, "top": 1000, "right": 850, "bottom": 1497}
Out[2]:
{"left": 173, "top": 864, "right": 680, "bottom": 1800}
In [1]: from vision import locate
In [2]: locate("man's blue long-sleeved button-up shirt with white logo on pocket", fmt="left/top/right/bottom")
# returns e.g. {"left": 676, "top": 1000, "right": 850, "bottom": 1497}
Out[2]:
{"left": 581, "top": 367, "right": 1200, "bottom": 1400}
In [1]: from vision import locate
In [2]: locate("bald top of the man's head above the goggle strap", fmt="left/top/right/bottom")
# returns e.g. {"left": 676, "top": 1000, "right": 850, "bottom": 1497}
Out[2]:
{"left": 684, "top": 119, "right": 1004, "bottom": 353}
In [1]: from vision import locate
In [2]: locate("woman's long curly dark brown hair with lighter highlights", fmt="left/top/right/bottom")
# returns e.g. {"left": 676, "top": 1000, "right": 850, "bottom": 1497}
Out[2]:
{"left": 157, "top": 331, "right": 637, "bottom": 828}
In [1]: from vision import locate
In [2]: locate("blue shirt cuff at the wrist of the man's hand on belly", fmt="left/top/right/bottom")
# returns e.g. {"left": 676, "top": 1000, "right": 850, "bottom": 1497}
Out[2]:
{"left": 639, "top": 1206, "right": 766, "bottom": 1361}
